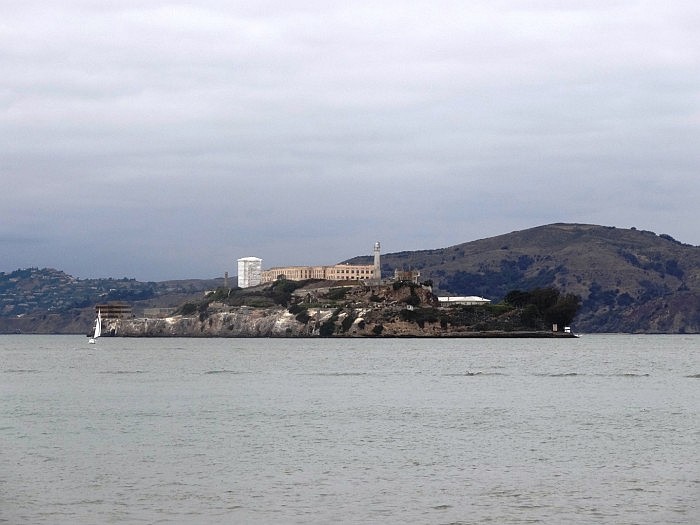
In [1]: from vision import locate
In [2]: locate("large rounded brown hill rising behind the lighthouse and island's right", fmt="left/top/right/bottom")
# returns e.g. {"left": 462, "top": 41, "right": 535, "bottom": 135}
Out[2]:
{"left": 348, "top": 224, "right": 700, "bottom": 333}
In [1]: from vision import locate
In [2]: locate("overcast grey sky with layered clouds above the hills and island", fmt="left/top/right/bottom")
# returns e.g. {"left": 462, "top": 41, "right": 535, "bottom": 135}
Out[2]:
{"left": 0, "top": 0, "right": 700, "bottom": 280}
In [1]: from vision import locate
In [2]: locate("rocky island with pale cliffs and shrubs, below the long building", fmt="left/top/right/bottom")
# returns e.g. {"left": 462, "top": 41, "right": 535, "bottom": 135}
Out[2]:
{"left": 102, "top": 278, "right": 580, "bottom": 337}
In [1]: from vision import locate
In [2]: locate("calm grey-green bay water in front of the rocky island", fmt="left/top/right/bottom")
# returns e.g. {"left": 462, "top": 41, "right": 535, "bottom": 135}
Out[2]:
{"left": 0, "top": 335, "right": 700, "bottom": 524}
